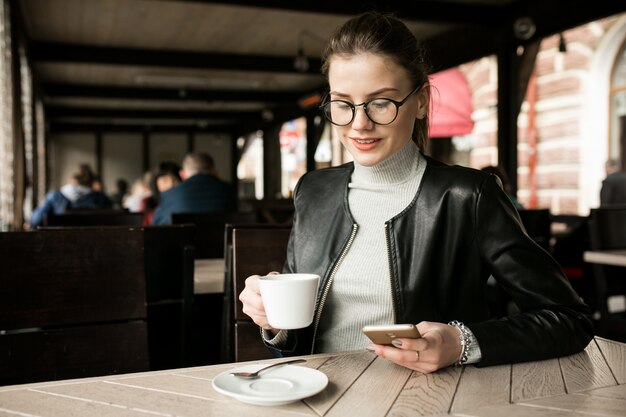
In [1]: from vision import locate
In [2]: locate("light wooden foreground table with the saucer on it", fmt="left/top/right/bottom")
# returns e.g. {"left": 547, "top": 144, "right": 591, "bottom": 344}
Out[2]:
{"left": 0, "top": 338, "right": 626, "bottom": 417}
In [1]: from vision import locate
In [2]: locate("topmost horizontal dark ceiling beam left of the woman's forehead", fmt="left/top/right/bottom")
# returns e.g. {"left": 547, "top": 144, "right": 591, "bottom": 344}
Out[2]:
{"left": 30, "top": 42, "right": 322, "bottom": 77}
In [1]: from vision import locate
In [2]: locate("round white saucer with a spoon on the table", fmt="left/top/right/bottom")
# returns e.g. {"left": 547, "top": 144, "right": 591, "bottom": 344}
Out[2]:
{"left": 213, "top": 364, "right": 328, "bottom": 405}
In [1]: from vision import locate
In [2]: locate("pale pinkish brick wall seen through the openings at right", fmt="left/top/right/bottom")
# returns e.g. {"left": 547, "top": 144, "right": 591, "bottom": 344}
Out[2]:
{"left": 460, "top": 17, "right": 618, "bottom": 214}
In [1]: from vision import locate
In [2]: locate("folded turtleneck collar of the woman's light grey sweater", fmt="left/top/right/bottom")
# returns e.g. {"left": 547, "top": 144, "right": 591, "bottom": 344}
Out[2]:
{"left": 351, "top": 141, "right": 423, "bottom": 187}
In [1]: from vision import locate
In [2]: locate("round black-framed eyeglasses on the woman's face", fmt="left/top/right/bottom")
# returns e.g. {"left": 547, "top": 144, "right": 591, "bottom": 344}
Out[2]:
{"left": 320, "top": 86, "right": 421, "bottom": 126}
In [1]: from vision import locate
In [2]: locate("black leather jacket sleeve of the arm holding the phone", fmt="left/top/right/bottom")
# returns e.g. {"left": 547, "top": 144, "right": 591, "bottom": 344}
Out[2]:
{"left": 468, "top": 180, "right": 593, "bottom": 366}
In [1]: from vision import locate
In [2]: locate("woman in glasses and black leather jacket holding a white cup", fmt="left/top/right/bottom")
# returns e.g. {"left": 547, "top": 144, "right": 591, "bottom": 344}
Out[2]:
{"left": 239, "top": 13, "right": 592, "bottom": 372}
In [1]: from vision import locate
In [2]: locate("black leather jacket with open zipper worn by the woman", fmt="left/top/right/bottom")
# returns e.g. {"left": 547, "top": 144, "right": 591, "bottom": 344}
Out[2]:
{"left": 275, "top": 158, "right": 593, "bottom": 366}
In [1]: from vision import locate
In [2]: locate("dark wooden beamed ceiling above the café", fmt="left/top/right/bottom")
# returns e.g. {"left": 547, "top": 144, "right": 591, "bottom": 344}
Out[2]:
{"left": 17, "top": 0, "right": 626, "bottom": 135}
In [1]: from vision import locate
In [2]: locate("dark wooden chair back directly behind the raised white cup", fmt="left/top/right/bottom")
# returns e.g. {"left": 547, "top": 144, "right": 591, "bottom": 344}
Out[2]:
{"left": 222, "top": 225, "right": 291, "bottom": 362}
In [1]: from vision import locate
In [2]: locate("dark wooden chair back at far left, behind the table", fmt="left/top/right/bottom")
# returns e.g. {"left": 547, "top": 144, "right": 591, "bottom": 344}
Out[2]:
{"left": 0, "top": 229, "right": 149, "bottom": 385}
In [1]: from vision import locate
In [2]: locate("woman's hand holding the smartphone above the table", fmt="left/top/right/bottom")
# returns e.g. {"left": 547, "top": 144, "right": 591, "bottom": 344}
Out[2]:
{"left": 369, "top": 321, "right": 461, "bottom": 373}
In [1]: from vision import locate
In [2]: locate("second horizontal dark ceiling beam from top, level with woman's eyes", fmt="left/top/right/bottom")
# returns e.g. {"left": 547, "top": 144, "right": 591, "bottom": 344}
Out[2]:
{"left": 42, "top": 83, "right": 310, "bottom": 103}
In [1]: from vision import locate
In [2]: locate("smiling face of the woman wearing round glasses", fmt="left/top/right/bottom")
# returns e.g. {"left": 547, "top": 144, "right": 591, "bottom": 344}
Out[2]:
{"left": 328, "top": 53, "right": 428, "bottom": 166}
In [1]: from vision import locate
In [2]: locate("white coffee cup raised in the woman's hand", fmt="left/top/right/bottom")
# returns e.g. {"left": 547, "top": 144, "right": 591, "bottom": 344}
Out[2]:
{"left": 259, "top": 274, "right": 320, "bottom": 329}
